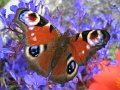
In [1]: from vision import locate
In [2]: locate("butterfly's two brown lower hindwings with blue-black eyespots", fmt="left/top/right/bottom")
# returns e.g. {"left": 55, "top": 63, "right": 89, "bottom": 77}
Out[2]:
{"left": 25, "top": 40, "right": 78, "bottom": 84}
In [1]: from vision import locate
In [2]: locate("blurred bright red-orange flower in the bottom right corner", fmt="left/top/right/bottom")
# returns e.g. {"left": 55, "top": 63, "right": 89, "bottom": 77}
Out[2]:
{"left": 89, "top": 49, "right": 120, "bottom": 90}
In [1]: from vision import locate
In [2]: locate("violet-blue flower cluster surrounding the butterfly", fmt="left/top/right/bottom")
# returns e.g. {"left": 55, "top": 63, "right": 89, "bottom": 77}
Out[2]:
{"left": 0, "top": 0, "right": 120, "bottom": 90}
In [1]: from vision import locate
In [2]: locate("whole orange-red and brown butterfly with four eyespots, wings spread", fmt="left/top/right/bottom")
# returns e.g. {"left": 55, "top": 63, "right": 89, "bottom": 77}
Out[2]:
{"left": 14, "top": 8, "right": 110, "bottom": 84}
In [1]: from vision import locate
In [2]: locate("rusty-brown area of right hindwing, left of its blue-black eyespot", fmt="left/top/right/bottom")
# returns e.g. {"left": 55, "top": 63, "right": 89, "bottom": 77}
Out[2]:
{"left": 50, "top": 55, "right": 67, "bottom": 83}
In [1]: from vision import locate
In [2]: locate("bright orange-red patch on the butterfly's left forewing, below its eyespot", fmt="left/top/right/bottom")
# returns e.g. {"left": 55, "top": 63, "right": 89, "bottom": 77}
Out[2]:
{"left": 25, "top": 26, "right": 59, "bottom": 45}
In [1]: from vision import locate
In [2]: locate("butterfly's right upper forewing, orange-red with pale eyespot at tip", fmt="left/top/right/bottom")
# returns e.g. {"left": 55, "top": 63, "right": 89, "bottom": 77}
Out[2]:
{"left": 70, "top": 29, "right": 110, "bottom": 65}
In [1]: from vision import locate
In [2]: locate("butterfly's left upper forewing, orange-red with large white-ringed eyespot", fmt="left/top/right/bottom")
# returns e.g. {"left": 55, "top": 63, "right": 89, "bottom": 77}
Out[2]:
{"left": 14, "top": 8, "right": 60, "bottom": 46}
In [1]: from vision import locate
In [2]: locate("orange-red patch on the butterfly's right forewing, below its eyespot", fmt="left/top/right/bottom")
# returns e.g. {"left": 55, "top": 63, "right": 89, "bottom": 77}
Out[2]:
{"left": 70, "top": 35, "right": 92, "bottom": 64}
